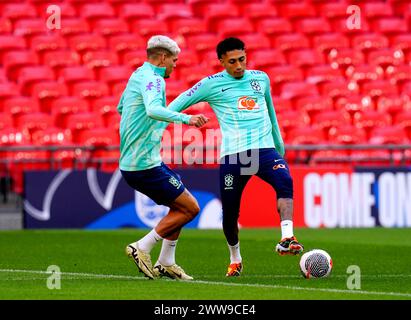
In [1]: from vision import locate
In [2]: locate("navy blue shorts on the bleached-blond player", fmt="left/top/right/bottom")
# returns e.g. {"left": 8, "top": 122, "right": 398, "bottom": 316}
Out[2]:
{"left": 121, "top": 163, "right": 185, "bottom": 205}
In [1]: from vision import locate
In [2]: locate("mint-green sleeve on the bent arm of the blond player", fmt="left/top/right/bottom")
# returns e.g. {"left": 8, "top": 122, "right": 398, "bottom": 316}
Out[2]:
{"left": 140, "top": 77, "right": 191, "bottom": 124}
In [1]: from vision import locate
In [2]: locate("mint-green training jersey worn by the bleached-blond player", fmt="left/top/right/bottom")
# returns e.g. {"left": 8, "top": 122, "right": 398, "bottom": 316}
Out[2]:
{"left": 117, "top": 62, "right": 191, "bottom": 171}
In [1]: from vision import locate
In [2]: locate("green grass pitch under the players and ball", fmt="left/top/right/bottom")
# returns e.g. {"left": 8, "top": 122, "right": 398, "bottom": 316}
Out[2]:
{"left": 0, "top": 228, "right": 411, "bottom": 300}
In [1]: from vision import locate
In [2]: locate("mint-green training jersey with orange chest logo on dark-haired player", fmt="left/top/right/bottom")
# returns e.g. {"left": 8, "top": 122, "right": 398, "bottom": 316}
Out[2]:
{"left": 169, "top": 70, "right": 284, "bottom": 157}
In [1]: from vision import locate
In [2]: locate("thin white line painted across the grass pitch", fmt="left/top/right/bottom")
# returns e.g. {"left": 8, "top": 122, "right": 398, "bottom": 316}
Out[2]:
{"left": 0, "top": 269, "right": 411, "bottom": 298}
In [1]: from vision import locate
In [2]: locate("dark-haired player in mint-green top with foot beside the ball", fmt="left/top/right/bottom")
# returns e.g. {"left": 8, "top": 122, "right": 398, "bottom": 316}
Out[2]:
{"left": 169, "top": 38, "right": 304, "bottom": 276}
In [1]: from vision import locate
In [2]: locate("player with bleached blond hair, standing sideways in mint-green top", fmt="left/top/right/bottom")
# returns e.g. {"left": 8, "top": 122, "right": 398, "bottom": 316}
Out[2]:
{"left": 117, "top": 35, "right": 208, "bottom": 280}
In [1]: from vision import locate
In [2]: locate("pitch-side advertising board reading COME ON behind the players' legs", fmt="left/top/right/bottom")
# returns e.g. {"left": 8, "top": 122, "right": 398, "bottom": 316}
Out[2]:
{"left": 2, "top": 146, "right": 411, "bottom": 229}
